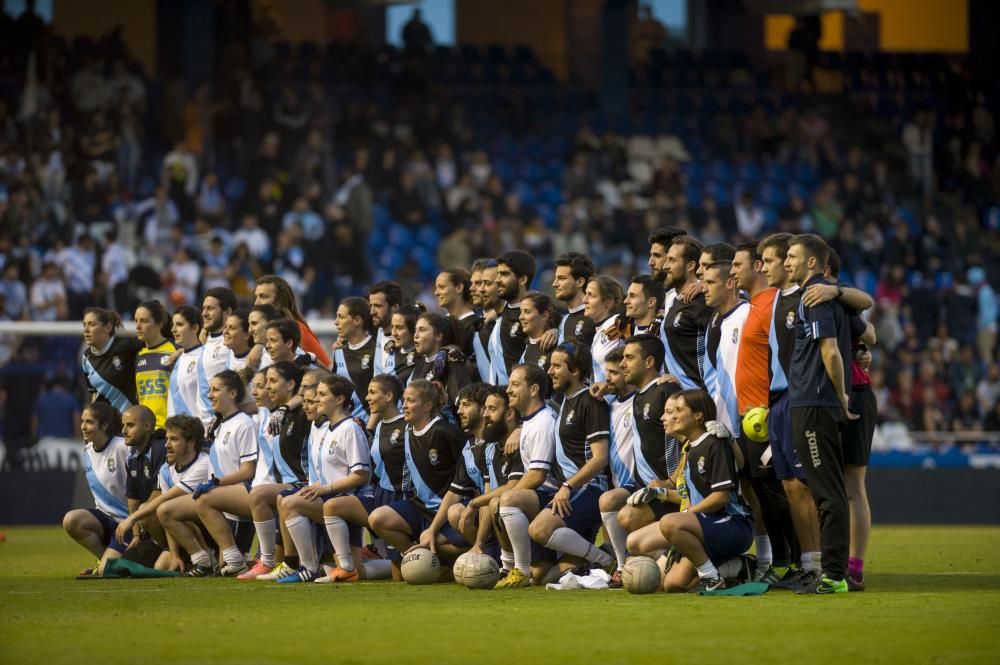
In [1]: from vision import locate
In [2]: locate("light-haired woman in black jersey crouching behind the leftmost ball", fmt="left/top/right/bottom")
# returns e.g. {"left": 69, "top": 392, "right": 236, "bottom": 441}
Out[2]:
{"left": 369, "top": 379, "right": 469, "bottom": 579}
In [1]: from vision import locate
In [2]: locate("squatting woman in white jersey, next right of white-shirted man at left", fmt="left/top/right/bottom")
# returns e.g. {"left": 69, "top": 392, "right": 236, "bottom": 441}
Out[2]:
{"left": 156, "top": 370, "right": 257, "bottom": 577}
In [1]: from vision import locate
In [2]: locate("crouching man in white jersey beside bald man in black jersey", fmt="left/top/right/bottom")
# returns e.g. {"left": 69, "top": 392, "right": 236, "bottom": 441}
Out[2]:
{"left": 116, "top": 407, "right": 212, "bottom": 570}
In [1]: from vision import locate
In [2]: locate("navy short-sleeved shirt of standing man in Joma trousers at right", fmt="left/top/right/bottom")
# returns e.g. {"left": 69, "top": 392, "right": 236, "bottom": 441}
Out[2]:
{"left": 788, "top": 275, "right": 851, "bottom": 407}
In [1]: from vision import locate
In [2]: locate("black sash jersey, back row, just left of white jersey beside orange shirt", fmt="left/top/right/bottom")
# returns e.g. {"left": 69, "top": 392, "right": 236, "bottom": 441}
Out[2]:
{"left": 660, "top": 294, "right": 713, "bottom": 390}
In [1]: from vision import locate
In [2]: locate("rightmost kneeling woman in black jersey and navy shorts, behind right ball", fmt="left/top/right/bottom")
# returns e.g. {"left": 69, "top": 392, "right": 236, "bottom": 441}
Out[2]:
{"left": 659, "top": 389, "right": 754, "bottom": 591}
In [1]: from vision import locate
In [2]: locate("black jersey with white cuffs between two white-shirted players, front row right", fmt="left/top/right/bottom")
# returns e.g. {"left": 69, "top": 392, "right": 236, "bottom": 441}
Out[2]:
{"left": 552, "top": 385, "right": 611, "bottom": 490}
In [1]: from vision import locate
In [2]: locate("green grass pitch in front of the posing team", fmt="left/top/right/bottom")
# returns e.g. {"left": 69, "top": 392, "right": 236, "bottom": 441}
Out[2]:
{"left": 0, "top": 527, "right": 1000, "bottom": 665}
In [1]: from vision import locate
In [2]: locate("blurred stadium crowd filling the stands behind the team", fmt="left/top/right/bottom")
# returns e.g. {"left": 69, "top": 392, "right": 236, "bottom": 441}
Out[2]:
{"left": 0, "top": 7, "right": 1000, "bottom": 456}
